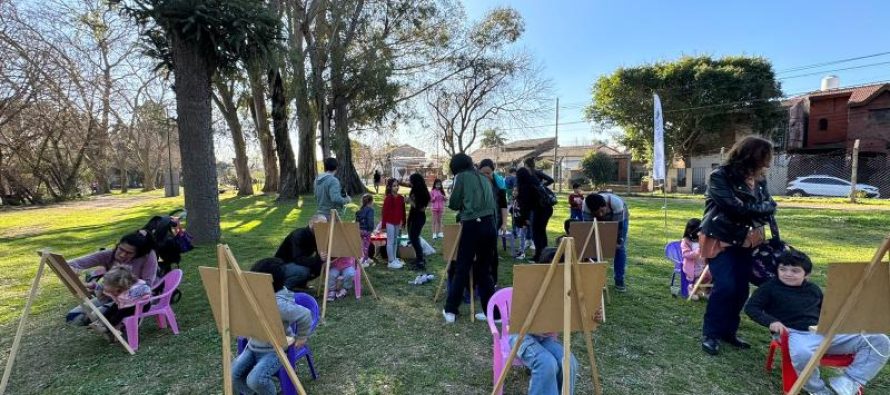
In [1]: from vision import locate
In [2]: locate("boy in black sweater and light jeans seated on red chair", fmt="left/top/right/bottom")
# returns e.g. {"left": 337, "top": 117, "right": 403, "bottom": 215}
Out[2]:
{"left": 745, "top": 251, "right": 890, "bottom": 395}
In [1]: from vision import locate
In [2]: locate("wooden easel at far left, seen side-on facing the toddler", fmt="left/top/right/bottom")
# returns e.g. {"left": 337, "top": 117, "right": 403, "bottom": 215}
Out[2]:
{"left": 0, "top": 248, "right": 135, "bottom": 394}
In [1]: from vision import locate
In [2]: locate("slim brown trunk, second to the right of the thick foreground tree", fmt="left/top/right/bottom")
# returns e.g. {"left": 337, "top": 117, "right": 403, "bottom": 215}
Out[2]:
{"left": 247, "top": 64, "right": 279, "bottom": 193}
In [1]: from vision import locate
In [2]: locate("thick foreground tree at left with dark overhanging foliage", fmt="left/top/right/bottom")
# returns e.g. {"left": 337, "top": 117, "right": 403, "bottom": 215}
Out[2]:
{"left": 114, "top": 0, "right": 279, "bottom": 243}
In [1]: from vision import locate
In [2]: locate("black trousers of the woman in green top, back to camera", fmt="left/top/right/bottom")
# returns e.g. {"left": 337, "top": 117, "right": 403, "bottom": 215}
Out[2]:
{"left": 445, "top": 215, "right": 498, "bottom": 315}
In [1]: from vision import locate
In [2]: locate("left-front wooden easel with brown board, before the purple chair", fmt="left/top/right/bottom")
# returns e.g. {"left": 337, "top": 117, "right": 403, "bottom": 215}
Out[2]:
{"left": 198, "top": 244, "right": 306, "bottom": 395}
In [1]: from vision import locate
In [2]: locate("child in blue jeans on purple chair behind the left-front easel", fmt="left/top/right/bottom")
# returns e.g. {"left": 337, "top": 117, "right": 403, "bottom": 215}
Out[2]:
{"left": 232, "top": 258, "right": 312, "bottom": 395}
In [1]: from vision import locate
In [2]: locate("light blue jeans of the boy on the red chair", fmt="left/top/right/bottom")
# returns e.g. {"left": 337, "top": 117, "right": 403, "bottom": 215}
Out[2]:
{"left": 788, "top": 329, "right": 890, "bottom": 392}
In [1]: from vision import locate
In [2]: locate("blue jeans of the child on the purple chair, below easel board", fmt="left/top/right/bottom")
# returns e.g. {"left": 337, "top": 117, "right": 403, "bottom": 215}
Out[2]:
{"left": 232, "top": 347, "right": 281, "bottom": 395}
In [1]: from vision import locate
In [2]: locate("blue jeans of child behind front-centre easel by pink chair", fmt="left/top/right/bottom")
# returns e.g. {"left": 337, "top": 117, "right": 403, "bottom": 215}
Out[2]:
{"left": 510, "top": 335, "right": 578, "bottom": 395}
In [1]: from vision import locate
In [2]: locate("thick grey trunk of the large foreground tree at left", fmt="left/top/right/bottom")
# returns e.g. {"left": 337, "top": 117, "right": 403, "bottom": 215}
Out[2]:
{"left": 171, "top": 32, "right": 220, "bottom": 244}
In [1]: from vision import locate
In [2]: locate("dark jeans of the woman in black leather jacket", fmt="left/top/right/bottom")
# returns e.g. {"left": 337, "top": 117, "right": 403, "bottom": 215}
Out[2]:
{"left": 702, "top": 246, "right": 754, "bottom": 339}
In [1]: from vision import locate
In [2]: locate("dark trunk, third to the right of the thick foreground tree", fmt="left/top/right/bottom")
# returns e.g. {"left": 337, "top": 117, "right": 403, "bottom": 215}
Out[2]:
{"left": 269, "top": 69, "right": 297, "bottom": 200}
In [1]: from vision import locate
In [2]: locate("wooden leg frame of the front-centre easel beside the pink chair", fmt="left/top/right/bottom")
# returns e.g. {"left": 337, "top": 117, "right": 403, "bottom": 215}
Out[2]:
{"left": 491, "top": 237, "right": 605, "bottom": 395}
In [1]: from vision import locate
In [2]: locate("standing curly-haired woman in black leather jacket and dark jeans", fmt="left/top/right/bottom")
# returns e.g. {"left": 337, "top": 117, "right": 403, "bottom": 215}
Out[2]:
{"left": 699, "top": 136, "right": 776, "bottom": 355}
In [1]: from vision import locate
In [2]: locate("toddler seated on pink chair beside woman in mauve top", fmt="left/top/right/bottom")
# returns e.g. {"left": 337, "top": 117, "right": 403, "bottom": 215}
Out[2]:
{"left": 89, "top": 266, "right": 151, "bottom": 341}
